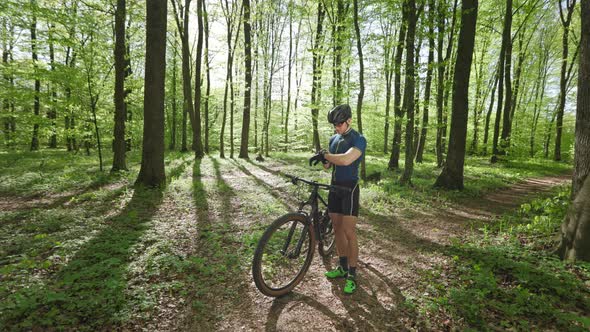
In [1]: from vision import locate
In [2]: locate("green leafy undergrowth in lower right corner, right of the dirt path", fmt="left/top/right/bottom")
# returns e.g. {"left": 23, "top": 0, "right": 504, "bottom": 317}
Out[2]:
{"left": 416, "top": 186, "right": 590, "bottom": 331}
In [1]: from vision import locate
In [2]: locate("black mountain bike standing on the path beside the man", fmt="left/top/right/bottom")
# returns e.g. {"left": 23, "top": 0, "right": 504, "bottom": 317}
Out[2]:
{"left": 252, "top": 175, "right": 351, "bottom": 297}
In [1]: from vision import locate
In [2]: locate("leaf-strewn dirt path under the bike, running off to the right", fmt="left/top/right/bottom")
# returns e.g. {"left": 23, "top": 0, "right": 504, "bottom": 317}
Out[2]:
{"left": 177, "top": 159, "right": 570, "bottom": 331}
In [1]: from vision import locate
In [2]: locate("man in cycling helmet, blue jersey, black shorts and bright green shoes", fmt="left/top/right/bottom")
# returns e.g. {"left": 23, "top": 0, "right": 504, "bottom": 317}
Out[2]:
{"left": 309, "top": 104, "right": 367, "bottom": 294}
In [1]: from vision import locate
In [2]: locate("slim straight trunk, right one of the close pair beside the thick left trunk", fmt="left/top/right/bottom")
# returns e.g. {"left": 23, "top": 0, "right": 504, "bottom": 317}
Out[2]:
{"left": 193, "top": 0, "right": 205, "bottom": 158}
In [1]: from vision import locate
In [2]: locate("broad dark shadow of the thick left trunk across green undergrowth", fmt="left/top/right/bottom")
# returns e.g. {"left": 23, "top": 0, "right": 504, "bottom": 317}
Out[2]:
{"left": 3, "top": 187, "right": 163, "bottom": 330}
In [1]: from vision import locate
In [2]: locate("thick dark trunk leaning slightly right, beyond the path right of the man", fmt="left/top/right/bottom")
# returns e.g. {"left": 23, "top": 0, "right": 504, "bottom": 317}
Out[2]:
{"left": 435, "top": 0, "right": 478, "bottom": 189}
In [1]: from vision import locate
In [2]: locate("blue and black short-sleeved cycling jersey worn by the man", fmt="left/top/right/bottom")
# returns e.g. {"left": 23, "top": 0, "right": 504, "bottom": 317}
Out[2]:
{"left": 329, "top": 128, "right": 367, "bottom": 182}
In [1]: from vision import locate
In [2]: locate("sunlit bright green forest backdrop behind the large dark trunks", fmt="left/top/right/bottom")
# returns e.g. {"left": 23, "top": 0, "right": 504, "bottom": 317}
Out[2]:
{"left": 0, "top": 0, "right": 580, "bottom": 165}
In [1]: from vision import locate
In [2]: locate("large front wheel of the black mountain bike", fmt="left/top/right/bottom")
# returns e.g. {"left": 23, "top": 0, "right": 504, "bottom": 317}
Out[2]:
{"left": 252, "top": 213, "right": 315, "bottom": 297}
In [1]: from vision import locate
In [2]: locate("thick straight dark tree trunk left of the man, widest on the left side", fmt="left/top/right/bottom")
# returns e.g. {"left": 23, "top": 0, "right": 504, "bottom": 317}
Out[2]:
{"left": 135, "top": 0, "right": 169, "bottom": 187}
